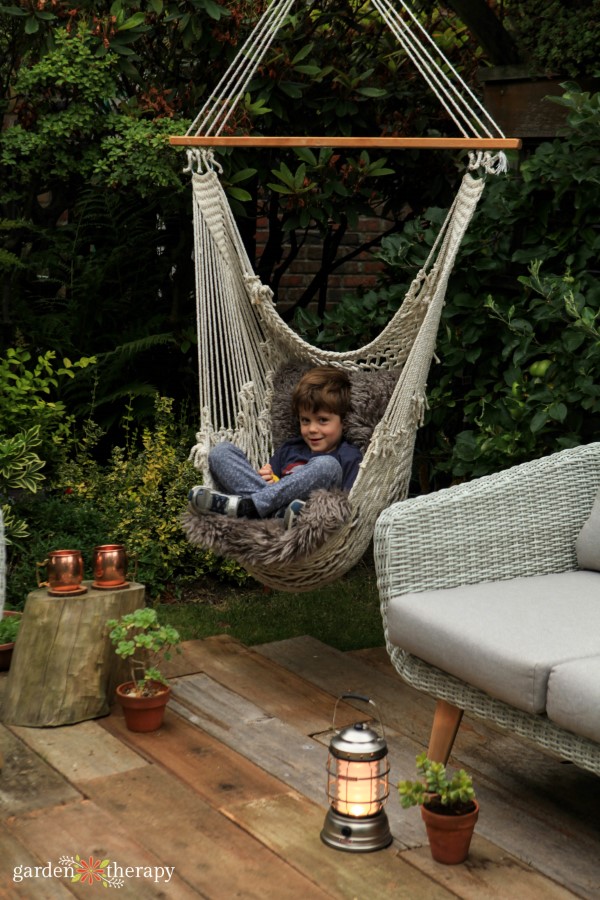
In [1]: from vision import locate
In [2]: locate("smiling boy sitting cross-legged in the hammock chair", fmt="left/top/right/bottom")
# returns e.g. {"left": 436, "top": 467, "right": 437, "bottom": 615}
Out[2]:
{"left": 188, "top": 366, "right": 362, "bottom": 528}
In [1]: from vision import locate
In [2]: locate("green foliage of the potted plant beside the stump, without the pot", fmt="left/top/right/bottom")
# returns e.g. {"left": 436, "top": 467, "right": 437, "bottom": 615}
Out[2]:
{"left": 106, "top": 608, "right": 181, "bottom": 697}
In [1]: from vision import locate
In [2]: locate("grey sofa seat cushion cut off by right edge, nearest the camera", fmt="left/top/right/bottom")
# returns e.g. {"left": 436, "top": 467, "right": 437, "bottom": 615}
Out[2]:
{"left": 546, "top": 656, "right": 600, "bottom": 742}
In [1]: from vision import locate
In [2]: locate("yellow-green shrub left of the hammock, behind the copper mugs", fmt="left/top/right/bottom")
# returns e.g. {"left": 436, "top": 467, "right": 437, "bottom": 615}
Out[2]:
{"left": 7, "top": 397, "right": 248, "bottom": 605}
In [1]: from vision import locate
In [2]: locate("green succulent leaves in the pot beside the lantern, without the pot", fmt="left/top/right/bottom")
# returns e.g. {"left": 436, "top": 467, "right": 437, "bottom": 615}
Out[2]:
{"left": 398, "top": 752, "right": 475, "bottom": 815}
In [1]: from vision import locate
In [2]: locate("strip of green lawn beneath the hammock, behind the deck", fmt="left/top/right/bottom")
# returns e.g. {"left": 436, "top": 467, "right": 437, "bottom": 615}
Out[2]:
{"left": 156, "top": 561, "right": 384, "bottom": 650}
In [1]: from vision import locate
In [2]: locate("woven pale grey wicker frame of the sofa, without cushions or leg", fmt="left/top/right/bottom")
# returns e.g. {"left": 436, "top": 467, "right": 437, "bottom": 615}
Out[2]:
{"left": 374, "top": 443, "right": 600, "bottom": 775}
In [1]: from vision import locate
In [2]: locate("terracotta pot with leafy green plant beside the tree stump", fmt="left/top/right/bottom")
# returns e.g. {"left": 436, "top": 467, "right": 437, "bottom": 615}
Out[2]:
{"left": 106, "top": 608, "right": 181, "bottom": 731}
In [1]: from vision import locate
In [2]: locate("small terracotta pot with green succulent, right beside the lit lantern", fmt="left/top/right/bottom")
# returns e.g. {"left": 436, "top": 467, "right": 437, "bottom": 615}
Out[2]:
{"left": 398, "top": 753, "right": 479, "bottom": 865}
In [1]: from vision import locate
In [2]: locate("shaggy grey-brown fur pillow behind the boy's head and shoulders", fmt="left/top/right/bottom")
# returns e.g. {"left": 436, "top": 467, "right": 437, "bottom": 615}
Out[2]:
{"left": 271, "top": 363, "right": 398, "bottom": 453}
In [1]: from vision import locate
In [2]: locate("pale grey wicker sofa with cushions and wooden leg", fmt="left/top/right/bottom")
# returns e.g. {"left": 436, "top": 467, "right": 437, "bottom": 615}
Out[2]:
{"left": 375, "top": 443, "right": 600, "bottom": 775}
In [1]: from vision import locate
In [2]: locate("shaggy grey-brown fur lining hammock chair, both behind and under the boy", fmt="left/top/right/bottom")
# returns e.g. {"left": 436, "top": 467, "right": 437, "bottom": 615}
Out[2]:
{"left": 182, "top": 363, "right": 398, "bottom": 566}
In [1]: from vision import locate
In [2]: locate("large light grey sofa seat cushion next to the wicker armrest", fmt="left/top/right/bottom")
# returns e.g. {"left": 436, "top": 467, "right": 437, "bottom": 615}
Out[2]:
{"left": 388, "top": 570, "right": 600, "bottom": 713}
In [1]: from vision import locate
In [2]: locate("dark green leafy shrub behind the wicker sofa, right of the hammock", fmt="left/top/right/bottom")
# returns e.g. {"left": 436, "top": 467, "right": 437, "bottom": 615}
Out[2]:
{"left": 292, "top": 90, "right": 600, "bottom": 490}
